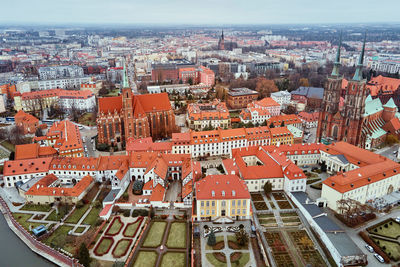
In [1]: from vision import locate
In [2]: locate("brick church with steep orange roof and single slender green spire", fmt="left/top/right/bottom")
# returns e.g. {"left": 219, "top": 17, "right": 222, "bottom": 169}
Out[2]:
{"left": 97, "top": 67, "right": 176, "bottom": 148}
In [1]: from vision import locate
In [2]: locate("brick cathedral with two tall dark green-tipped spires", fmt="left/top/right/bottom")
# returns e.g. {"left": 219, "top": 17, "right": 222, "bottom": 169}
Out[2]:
{"left": 317, "top": 33, "right": 400, "bottom": 149}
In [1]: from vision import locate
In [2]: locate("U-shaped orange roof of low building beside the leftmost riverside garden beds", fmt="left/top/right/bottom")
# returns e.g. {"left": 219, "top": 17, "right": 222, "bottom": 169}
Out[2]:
{"left": 25, "top": 174, "right": 93, "bottom": 197}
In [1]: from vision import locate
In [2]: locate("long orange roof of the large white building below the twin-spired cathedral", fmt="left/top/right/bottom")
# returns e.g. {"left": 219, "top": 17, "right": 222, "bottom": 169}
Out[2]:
{"left": 323, "top": 158, "right": 400, "bottom": 193}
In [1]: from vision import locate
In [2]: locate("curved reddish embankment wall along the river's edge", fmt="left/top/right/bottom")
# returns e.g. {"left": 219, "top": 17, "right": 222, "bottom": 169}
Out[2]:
{"left": 0, "top": 197, "right": 83, "bottom": 267}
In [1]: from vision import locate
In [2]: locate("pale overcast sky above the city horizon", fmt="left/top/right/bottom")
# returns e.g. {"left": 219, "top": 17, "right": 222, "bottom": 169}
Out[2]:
{"left": 0, "top": 0, "right": 400, "bottom": 25}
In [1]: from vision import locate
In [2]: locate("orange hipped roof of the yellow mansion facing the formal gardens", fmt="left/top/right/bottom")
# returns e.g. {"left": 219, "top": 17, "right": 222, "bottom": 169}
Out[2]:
{"left": 196, "top": 174, "right": 250, "bottom": 200}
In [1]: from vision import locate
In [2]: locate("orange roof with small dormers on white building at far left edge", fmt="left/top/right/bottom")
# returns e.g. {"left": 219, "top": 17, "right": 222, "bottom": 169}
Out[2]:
{"left": 3, "top": 158, "right": 52, "bottom": 176}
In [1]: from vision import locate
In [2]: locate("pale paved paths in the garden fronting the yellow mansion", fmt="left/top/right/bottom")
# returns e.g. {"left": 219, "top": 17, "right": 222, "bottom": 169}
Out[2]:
{"left": 199, "top": 221, "right": 257, "bottom": 267}
